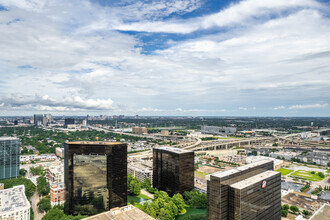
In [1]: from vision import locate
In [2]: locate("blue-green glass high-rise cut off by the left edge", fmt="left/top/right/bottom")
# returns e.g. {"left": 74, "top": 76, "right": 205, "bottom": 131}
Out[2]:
{"left": 0, "top": 137, "right": 20, "bottom": 180}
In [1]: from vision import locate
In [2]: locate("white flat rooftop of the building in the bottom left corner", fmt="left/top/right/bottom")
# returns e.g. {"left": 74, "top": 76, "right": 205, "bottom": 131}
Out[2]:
{"left": 0, "top": 185, "right": 30, "bottom": 214}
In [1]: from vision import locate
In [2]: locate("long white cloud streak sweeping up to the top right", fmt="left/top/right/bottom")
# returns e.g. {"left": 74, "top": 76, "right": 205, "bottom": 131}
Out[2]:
{"left": 114, "top": 0, "right": 321, "bottom": 33}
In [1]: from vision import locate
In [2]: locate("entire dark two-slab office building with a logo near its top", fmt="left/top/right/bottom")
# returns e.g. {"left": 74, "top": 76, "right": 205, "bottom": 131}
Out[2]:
{"left": 206, "top": 160, "right": 281, "bottom": 220}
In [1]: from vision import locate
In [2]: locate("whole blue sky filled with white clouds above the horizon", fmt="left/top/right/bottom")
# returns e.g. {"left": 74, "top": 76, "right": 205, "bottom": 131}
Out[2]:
{"left": 0, "top": 0, "right": 330, "bottom": 116}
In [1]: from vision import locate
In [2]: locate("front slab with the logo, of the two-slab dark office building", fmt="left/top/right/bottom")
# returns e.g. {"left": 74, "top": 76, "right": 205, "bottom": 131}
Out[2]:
{"left": 229, "top": 170, "right": 281, "bottom": 220}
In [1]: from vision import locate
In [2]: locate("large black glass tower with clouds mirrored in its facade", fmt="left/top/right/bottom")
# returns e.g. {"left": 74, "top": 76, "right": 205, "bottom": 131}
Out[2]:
{"left": 64, "top": 141, "right": 127, "bottom": 215}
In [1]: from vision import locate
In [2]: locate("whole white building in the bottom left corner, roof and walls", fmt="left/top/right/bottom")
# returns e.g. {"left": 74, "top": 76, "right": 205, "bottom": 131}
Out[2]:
{"left": 0, "top": 185, "right": 31, "bottom": 220}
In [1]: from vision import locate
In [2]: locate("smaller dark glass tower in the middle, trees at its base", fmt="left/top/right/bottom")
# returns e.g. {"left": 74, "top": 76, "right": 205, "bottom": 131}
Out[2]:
{"left": 153, "top": 147, "right": 194, "bottom": 195}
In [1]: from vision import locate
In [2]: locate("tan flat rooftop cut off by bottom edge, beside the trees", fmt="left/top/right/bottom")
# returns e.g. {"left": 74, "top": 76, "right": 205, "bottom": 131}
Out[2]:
{"left": 84, "top": 205, "right": 154, "bottom": 220}
